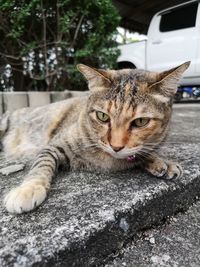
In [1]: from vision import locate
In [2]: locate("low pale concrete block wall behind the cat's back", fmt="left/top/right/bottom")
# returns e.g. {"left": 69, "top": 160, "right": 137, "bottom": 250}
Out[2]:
{"left": 0, "top": 90, "right": 87, "bottom": 115}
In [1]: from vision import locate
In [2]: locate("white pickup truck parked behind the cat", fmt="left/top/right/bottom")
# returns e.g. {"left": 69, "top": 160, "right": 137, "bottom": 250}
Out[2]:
{"left": 118, "top": 1, "right": 200, "bottom": 85}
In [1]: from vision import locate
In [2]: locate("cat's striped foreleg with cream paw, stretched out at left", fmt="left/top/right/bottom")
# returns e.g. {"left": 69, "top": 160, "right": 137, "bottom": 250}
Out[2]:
{"left": 4, "top": 145, "right": 69, "bottom": 213}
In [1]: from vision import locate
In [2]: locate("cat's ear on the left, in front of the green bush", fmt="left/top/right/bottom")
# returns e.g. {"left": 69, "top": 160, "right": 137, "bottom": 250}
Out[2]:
{"left": 77, "top": 64, "right": 111, "bottom": 91}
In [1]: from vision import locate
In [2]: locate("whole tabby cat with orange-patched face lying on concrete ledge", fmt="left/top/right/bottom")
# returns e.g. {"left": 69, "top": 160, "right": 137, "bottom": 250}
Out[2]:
{"left": 0, "top": 62, "right": 190, "bottom": 213}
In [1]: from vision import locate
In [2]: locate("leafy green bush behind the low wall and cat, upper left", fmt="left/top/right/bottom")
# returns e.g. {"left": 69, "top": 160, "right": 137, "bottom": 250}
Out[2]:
{"left": 0, "top": 0, "right": 120, "bottom": 90}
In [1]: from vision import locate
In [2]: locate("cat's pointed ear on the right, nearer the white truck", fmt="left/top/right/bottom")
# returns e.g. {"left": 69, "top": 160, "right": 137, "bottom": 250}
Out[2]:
{"left": 149, "top": 61, "right": 190, "bottom": 99}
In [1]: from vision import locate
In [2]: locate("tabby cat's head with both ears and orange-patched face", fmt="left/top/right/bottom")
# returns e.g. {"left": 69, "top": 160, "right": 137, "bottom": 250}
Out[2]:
{"left": 77, "top": 62, "right": 190, "bottom": 158}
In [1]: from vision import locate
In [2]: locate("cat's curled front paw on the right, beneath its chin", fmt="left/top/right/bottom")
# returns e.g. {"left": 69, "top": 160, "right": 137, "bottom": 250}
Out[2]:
{"left": 144, "top": 153, "right": 183, "bottom": 179}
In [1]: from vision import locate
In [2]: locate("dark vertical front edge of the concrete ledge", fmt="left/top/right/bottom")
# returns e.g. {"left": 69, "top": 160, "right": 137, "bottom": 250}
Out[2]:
{"left": 38, "top": 174, "right": 200, "bottom": 267}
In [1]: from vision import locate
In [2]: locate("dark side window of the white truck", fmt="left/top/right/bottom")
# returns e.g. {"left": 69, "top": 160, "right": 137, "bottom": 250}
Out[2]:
{"left": 160, "top": 3, "right": 198, "bottom": 32}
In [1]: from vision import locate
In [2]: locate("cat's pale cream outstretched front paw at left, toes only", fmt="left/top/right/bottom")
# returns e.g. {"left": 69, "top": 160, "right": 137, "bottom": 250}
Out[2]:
{"left": 4, "top": 181, "right": 47, "bottom": 213}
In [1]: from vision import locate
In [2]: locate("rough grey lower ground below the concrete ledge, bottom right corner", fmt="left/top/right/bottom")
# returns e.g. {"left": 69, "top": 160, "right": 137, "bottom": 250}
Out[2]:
{"left": 105, "top": 202, "right": 200, "bottom": 267}
